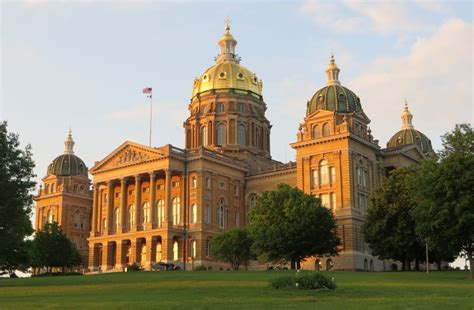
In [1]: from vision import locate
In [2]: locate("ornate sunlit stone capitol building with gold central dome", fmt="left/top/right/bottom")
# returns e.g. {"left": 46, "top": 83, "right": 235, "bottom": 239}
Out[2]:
{"left": 35, "top": 23, "right": 433, "bottom": 272}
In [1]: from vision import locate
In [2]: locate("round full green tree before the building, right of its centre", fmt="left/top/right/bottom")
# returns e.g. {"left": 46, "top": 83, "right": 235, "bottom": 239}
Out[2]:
{"left": 249, "top": 184, "right": 339, "bottom": 269}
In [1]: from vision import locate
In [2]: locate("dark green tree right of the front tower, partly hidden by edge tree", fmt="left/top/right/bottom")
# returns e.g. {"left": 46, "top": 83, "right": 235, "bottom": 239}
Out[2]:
{"left": 362, "top": 167, "right": 424, "bottom": 270}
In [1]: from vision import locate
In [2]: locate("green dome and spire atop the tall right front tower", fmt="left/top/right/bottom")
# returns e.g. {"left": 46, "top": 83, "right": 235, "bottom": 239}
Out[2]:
{"left": 306, "top": 55, "right": 362, "bottom": 115}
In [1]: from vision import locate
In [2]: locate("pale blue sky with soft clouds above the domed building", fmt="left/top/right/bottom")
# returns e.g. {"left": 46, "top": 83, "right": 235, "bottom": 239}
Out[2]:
{"left": 0, "top": 0, "right": 474, "bottom": 186}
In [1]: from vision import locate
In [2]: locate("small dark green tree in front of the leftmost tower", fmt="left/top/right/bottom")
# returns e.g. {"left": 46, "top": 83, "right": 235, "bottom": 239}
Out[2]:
{"left": 32, "top": 222, "right": 81, "bottom": 274}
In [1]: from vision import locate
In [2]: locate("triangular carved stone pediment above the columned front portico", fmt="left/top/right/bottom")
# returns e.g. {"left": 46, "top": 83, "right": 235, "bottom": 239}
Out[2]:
{"left": 90, "top": 141, "right": 165, "bottom": 174}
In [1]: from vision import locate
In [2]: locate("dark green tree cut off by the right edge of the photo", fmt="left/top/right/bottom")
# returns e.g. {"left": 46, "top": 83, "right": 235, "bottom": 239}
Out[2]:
{"left": 413, "top": 124, "right": 474, "bottom": 279}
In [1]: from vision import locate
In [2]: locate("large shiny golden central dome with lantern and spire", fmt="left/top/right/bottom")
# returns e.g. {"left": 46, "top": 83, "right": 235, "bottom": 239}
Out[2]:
{"left": 192, "top": 19, "right": 262, "bottom": 98}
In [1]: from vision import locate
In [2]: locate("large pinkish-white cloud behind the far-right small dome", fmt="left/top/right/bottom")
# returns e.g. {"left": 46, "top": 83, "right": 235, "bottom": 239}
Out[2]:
{"left": 347, "top": 19, "right": 473, "bottom": 150}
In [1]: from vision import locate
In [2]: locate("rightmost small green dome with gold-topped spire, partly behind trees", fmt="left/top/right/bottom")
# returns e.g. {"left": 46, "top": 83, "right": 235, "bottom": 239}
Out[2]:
{"left": 387, "top": 102, "right": 433, "bottom": 154}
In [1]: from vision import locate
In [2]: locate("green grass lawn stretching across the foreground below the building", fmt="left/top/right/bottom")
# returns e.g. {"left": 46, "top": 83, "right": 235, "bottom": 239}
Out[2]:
{"left": 0, "top": 271, "right": 474, "bottom": 310}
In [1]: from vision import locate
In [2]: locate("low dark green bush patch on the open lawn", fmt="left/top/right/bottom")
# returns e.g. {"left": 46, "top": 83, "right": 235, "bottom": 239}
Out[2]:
{"left": 270, "top": 271, "right": 336, "bottom": 290}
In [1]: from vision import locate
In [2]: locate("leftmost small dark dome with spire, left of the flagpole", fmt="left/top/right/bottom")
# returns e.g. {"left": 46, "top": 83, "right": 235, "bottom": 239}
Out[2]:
{"left": 48, "top": 130, "right": 88, "bottom": 177}
